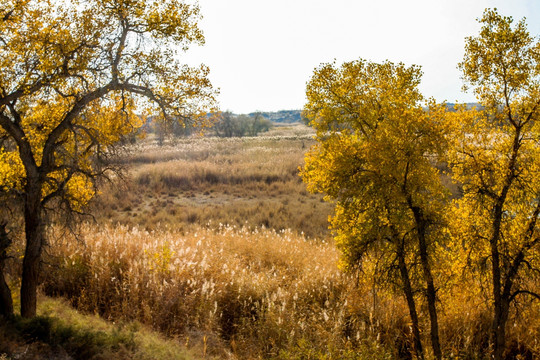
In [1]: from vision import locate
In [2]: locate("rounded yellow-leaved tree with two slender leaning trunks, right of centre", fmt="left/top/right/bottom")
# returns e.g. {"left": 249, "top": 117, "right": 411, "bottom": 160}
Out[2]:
{"left": 301, "top": 60, "right": 446, "bottom": 359}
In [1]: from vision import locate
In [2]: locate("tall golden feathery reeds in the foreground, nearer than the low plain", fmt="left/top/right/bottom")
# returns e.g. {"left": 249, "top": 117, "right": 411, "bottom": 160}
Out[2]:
{"left": 39, "top": 225, "right": 404, "bottom": 359}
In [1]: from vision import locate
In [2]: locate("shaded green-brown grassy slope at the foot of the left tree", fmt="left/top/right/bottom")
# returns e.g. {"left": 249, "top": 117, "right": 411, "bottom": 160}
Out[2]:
{"left": 0, "top": 296, "right": 206, "bottom": 360}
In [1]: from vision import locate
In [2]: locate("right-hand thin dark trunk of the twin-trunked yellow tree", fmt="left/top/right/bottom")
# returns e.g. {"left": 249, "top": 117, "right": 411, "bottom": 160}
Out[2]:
{"left": 412, "top": 207, "right": 442, "bottom": 360}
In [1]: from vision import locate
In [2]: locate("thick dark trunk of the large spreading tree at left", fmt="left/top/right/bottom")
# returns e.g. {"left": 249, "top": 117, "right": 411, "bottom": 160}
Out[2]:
{"left": 21, "top": 186, "right": 44, "bottom": 318}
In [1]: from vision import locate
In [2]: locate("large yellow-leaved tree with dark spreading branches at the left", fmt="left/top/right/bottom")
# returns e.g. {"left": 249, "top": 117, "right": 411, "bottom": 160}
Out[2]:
{"left": 0, "top": 0, "right": 219, "bottom": 317}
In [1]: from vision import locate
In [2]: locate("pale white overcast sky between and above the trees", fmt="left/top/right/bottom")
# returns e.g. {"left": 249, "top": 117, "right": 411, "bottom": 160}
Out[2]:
{"left": 181, "top": 0, "right": 540, "bottom": 113}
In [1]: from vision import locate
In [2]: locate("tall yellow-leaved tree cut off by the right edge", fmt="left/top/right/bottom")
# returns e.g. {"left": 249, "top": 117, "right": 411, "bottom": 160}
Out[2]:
{"left": 449, "top": 9, "right": 540, "bottom": 359}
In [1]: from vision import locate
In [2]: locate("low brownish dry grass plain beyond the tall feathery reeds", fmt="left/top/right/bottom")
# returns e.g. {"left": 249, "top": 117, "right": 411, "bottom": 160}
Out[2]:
{"left": 90, "top": 127, "right": 332, "bottom": 238}
